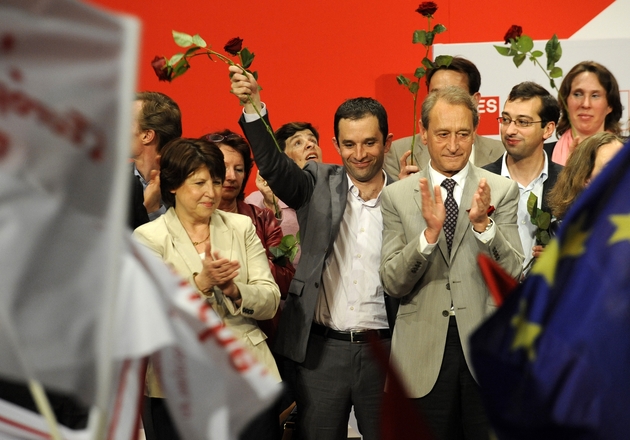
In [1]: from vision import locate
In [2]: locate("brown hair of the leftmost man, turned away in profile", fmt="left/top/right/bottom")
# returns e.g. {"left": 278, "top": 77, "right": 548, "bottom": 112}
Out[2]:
{"left": 136, "top": 92, "right": 182, "bottom": 153}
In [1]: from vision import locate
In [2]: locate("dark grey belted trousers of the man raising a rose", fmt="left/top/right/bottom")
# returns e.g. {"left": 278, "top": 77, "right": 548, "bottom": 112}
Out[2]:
{"left": 295, "top": 334, "right": 391, "bottom": 440}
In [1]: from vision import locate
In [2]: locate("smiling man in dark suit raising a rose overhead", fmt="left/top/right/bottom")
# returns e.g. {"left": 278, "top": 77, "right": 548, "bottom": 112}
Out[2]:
{"left": 230, "top": 67, "right": 392, "bottom": 440}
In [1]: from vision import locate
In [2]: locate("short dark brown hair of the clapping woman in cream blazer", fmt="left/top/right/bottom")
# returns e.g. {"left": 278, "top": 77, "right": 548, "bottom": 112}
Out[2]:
{"left": 160, "top": 138, "right": 225, "bottom": 207}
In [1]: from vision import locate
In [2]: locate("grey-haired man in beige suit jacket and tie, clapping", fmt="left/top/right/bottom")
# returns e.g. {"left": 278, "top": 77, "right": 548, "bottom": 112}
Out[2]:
{"left": 380, "top": 87, "right": 523, "bottom": 439}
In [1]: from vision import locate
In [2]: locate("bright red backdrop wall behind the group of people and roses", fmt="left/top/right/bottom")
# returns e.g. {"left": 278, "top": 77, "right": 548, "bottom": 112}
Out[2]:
{"left": 90, "top": 0, "right": 612, "bottom": 189}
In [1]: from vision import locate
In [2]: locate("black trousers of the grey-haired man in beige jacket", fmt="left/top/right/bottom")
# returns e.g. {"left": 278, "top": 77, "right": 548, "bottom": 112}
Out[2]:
{"left": 412, "top": 316, "right": 490, "bottom": 440}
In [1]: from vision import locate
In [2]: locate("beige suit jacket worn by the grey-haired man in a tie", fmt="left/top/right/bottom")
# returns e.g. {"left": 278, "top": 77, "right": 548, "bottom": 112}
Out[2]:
{"left": 380, "top": 164, "right": 523, "bottom": 398}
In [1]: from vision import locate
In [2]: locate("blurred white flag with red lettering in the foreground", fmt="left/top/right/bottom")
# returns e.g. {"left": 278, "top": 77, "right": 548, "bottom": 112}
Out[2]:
{"left": 0, "top": 0, "right": 280, "bottom": 440}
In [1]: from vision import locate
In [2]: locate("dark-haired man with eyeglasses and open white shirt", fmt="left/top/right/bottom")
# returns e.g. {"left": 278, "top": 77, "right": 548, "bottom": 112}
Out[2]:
{"left": 484, "top": 81, "right": 562, "bottom": 268}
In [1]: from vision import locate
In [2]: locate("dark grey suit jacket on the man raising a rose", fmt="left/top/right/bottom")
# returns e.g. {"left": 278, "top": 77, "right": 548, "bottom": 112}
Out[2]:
{"left": 239, "top": 117, "right": 396, "bottom": 362}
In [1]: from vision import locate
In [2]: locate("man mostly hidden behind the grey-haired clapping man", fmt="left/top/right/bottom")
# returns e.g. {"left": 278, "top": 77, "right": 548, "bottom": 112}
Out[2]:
{"left": 384, "top": 57, "right": 505, "bottom": 180}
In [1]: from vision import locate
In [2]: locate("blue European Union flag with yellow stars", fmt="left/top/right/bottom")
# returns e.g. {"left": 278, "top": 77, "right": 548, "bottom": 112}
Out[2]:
{"left": 471, "top": 140, "right": 630, "bottom": 440}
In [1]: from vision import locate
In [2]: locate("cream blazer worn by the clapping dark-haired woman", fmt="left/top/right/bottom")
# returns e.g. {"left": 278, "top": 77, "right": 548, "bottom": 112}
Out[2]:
{"left": 133, "top": 208, "right": 280, "bottom": 390}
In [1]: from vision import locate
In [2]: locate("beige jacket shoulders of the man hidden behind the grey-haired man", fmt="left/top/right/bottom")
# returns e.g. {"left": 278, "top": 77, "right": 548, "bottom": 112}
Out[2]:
{"left": 383, "top": 134, "right": 505, "bottom": 180}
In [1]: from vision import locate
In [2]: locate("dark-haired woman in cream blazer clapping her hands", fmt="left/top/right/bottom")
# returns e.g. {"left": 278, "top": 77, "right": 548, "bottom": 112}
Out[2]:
{"left": 133, "top": 138, "right": 280, "bottom": 438}
